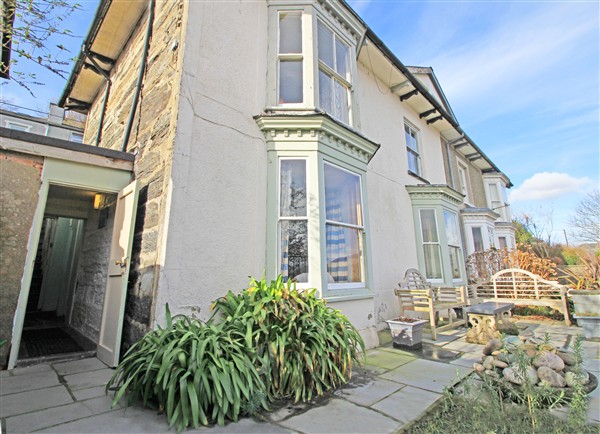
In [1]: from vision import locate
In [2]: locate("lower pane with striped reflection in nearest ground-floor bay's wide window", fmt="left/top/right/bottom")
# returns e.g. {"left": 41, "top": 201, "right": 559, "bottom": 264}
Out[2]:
{"left": 326, "top": 223, "right": 362, "bottom": 283}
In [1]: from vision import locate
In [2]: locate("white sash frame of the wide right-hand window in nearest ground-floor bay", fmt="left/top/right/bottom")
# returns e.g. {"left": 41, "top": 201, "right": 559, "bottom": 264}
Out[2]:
{"left": 321, "top": 160, "right": 366, "bottom": 291}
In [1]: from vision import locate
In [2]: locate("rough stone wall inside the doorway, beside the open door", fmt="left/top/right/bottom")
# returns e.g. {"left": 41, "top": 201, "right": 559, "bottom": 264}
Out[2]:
{"left": 71, "top": 203, "right": 116, "bottom": 342}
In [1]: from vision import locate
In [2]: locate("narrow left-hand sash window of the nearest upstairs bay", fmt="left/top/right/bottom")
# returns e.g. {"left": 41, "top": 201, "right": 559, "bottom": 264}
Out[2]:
{"left": 277, "top": 11, "right": 304, "bottom": 105}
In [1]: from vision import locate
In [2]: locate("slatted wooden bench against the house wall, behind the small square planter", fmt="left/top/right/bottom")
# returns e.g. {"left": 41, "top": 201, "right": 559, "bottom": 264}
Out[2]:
{"left": 395, "top": 268, "right": 467, "bottom": 340}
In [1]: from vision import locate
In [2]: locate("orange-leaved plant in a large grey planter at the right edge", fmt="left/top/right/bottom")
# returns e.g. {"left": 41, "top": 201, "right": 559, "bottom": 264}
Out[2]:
{"left": 567, "top": 251, "right": 600, "bottom": 339}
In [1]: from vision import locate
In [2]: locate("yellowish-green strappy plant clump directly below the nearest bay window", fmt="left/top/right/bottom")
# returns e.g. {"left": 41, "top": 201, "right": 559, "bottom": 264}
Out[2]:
{"left": 214, "top": 276, "right": 365, "bottom": 401}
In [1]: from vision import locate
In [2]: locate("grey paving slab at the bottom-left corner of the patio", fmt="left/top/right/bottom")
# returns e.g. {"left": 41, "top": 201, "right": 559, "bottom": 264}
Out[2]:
{"left": 6, "top": 402, "right": 94, "bottom": 433}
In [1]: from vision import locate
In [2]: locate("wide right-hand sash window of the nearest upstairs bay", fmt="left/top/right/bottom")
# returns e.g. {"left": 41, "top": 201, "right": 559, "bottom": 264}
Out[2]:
{"left": 317, "top": 21, "right": 352, "bottom": 124}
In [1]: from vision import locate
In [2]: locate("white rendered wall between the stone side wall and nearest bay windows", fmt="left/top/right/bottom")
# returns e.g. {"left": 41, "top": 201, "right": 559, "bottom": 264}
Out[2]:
{"left": 156, "top": 2, "right": 268, "bottom": 321}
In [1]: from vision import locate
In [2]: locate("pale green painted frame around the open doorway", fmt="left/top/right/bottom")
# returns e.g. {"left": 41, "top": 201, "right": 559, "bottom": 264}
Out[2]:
{"left": 8, "top": 157, "right": 132, "bottom": 369}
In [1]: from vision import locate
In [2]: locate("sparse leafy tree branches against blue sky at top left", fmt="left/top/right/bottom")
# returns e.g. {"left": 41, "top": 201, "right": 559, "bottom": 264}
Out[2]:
{"left": 0, "top": 0, "right": 81, "bottom": 95}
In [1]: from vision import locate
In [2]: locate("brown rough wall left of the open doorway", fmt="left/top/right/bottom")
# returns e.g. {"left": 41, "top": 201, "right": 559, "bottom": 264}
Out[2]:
{"left": 0, "top": 151, "right": 43, "bottom": 366}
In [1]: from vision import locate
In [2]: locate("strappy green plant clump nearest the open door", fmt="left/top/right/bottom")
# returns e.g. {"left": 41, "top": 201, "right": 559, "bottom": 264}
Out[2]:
{"left": 106, "top": 306, "right": 268, "bottom": 431}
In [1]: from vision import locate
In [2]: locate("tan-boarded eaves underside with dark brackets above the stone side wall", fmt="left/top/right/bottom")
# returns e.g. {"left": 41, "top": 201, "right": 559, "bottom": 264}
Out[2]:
{"left": 58, "top": 0, "right": 147, "bottom": 113}
